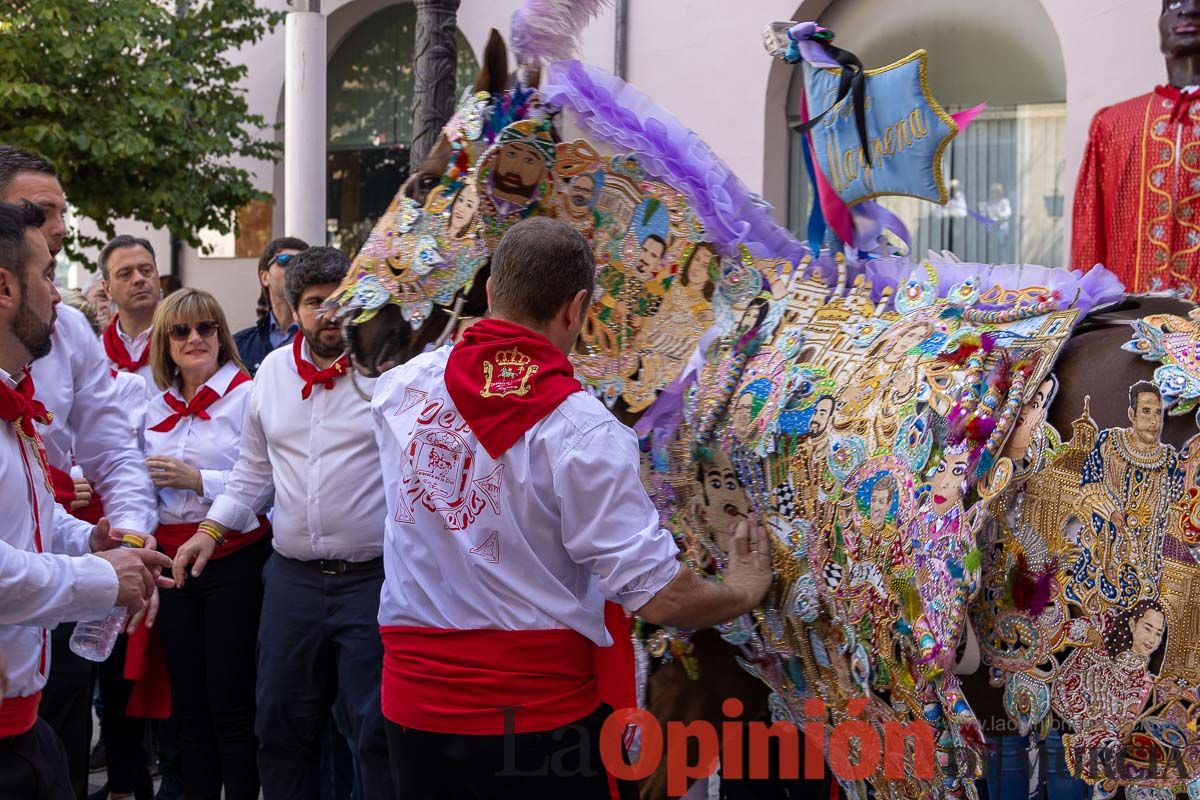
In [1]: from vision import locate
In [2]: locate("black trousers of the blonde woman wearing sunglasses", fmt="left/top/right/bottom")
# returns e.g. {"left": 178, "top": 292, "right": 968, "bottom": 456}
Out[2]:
{"left": 158, "top": 537, "right": 271, "bottom": 800}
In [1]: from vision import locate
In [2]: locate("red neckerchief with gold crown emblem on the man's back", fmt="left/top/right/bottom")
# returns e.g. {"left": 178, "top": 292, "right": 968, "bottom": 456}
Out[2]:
{"left": 445, "top": 319, "right": 581, "bottom": 458}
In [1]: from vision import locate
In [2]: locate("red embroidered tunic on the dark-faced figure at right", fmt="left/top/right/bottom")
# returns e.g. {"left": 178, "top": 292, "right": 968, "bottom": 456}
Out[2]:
{"left": 1070, "top": 86, "right": 1200, "bottom": 300}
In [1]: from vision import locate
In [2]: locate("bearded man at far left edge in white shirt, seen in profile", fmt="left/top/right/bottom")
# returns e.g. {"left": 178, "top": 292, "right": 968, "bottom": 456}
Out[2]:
{"left": 0, "top": 203, "right": 169, "bottom": 800}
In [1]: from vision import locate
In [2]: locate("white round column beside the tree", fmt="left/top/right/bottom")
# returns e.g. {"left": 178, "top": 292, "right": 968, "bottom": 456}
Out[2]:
{"left": 283, "top": 0, "right": 326, "bottom": 245}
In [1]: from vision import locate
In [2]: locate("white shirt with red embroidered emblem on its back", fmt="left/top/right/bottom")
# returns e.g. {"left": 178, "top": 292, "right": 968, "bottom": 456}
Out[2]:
{"left": 372, "top": 345, "right": 679, "bottom": 645}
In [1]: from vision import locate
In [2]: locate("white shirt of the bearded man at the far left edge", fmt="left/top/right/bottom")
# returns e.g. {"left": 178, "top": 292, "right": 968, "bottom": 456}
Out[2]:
{"left": 0, "top": 369, "right": 116, "bottom": 697}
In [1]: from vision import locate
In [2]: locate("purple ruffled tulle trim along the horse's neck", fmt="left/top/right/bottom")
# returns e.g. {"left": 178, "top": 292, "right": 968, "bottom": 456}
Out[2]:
{"left": 541, "top": 61, "right": 809, "bottom": 261}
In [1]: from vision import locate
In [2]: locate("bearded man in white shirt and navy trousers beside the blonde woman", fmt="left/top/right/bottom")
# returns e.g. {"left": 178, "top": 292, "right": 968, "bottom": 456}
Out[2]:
{"left": 174, "top": 247, "right": 394, "bottom": 800}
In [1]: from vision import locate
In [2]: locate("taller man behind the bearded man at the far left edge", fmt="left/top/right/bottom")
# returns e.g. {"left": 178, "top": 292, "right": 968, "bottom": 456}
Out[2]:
{"left": 0, "top": 145, "right": 158, "bottom": 798}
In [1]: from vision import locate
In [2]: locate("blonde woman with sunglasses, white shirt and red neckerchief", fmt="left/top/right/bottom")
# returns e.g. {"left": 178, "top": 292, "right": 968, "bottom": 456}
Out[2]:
{"left": 145, "top": 289, "right": 271, "bottom": 800}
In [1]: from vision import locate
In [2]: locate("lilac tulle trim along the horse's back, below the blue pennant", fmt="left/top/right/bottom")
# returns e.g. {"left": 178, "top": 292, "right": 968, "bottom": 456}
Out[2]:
{"left": 860, "top": 258, "right": 1126, "bottom": 314}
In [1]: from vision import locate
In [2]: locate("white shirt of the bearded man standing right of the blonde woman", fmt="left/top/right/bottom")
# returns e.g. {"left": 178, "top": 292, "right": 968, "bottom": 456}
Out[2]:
{"left": 209, "top": 342, "right": 386, "bottom": 561}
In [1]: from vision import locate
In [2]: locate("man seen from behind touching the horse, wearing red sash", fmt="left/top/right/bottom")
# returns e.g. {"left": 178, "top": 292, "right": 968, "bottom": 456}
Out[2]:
{"left": 372, "top": 217, "right": 772, "bottom": 800}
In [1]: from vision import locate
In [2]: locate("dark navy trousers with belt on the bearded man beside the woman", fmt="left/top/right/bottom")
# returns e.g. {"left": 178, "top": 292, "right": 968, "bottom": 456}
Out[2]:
{"left": 254, "top": 553, "right": 392, "bottom": 800}
